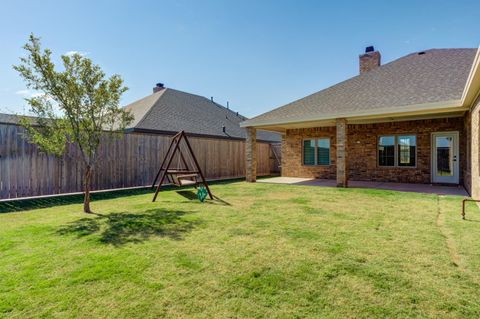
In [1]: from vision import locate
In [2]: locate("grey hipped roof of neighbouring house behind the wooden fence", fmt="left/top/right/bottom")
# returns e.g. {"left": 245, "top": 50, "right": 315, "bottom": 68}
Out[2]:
{"left": 125, "top": 88, "right": 281, "bottom": 142}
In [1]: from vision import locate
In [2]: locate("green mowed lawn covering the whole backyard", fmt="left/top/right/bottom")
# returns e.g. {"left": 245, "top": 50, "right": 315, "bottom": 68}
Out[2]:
{"left": 0, "top": 182, "right": 480, "bottom": 318}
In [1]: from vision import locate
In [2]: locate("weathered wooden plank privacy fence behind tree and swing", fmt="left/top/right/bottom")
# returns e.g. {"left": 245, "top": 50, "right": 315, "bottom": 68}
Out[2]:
{"left": 0, "top": 124, "right": 277, "bottom": 199}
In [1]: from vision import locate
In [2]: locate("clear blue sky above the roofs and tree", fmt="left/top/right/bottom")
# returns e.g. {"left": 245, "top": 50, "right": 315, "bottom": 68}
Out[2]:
{"left": 0, "top": 0, "right": 480, "bottom": 117}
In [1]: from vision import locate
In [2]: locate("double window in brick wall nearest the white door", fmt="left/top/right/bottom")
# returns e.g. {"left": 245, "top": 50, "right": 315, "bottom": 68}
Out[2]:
{"left": 378, "top": 135, "right": 417, "bottom": 167}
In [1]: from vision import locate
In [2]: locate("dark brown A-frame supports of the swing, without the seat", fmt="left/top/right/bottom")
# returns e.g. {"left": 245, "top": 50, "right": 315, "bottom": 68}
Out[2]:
{"left": 152, "top": 131, "right": 213, "bottom": 202}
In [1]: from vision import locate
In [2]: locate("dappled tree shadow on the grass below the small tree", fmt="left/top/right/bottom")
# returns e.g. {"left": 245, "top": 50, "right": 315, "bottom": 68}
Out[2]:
{"left": 57, "top": 209, "right": 201, "bottom": 246}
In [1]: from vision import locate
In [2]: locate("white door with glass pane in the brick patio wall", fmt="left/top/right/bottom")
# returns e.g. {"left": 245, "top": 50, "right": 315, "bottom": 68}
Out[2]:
{"left": 432, "top": 132, "right": 460, "bottom": 184}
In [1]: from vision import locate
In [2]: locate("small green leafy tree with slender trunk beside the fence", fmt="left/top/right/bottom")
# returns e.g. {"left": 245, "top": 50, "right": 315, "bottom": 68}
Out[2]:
{"left": 13, "top": 34, "right": 133, "bottom": 213}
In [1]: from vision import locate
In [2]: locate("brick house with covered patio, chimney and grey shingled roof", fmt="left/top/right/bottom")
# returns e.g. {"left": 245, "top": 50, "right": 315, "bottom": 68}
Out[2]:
{"left": 241, "top": 47, "right": 480, "bottom": 198}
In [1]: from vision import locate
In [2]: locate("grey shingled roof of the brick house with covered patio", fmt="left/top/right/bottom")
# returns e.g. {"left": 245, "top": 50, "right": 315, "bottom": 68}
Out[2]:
{"left": 242, "top": 49, "right": 477, "bottom": 126}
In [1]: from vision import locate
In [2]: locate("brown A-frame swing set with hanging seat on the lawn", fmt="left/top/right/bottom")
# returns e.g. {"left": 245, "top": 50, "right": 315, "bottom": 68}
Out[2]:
{"left": 152, "top": 131, "right": 213, "bottom": 202}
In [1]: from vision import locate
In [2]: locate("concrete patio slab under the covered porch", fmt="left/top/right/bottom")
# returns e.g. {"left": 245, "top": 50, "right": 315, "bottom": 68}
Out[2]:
{"left": 257, "top": 177, "right": 468, "bottom": 196}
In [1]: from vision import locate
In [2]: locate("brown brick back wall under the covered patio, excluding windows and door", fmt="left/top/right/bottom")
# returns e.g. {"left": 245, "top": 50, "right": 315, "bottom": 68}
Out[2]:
{"left": 282, "top": 117, "right": 466, "bottom": 183}
